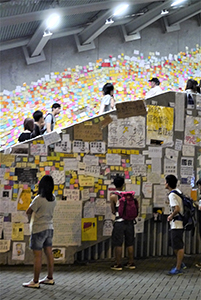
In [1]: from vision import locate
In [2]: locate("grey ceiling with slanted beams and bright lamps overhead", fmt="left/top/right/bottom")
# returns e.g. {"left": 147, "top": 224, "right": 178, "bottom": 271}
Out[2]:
{"left": 0, "top": 0, "right": 201, "bottom": 64}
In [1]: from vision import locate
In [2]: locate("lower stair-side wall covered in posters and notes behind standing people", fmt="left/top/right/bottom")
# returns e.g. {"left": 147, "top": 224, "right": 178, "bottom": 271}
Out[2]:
{"left": 0, "top": 92, "right": 201, "bottom": 264}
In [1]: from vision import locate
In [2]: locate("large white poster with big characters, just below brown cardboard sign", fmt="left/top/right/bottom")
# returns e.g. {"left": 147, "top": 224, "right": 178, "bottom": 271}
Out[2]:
{"left": 108, "top": 116, "right": 145, "bottom": 148}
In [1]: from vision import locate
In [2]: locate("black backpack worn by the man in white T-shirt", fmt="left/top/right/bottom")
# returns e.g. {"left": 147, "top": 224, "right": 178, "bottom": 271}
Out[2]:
{"left": 171, "top": 190, "right": 196, "bottom": 235}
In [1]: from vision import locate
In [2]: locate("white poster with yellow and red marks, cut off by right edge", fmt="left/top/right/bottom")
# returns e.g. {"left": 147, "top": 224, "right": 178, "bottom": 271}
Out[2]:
{"left": 184, "top": 116, "right": 201, "bottom": 146}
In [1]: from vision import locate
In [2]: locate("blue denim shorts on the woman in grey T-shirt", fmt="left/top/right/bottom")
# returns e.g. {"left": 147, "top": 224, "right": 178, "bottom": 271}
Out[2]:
{"left": 30, "top": 229, "right": 53, "bottom": 250}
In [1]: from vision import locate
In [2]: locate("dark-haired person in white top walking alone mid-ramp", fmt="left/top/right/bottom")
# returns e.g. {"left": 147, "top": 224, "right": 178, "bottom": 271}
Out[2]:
{"left": 99, "top": 83, "right": 114, "bottom": 114}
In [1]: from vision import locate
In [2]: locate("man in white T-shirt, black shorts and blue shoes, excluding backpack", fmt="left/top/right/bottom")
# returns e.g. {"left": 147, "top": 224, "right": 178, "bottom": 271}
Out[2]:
{"left": 165, "top": 175, "right": 186, "bottom": 275}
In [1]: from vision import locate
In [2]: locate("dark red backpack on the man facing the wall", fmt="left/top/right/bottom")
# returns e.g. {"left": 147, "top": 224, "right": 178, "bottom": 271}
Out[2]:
{"left": 115, "top": 192, "right": 138, "bottom": 221}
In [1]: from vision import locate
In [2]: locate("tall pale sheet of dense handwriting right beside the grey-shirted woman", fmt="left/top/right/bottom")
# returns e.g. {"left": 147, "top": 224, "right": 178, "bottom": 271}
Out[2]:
{"left": 53, "top": 200, "right": 82, "bottom": 246}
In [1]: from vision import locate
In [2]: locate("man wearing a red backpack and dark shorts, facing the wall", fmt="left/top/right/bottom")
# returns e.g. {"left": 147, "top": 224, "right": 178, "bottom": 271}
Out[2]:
{"left": 110, "top": 175, "right": 138, "bottom": 271}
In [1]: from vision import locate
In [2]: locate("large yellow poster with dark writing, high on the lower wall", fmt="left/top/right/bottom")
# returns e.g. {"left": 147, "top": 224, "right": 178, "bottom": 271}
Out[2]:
{"left": 147, "top": 105, "right": 174, "bottom": 144}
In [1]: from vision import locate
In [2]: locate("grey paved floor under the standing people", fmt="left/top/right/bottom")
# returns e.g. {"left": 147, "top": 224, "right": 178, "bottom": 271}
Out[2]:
{"left": 0, "top": 256, "right": 201, "bottom": 300}
